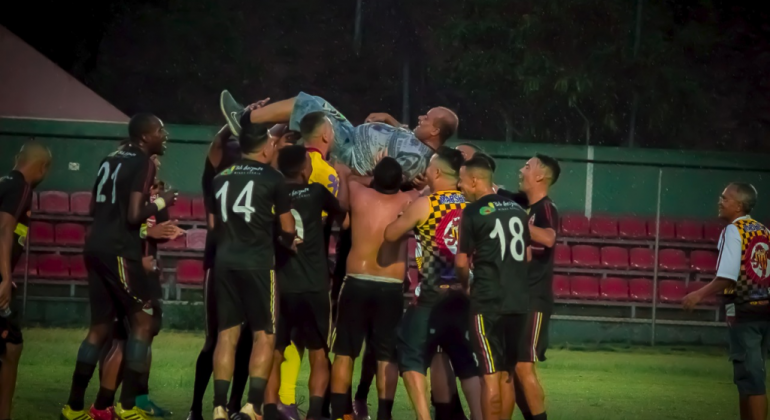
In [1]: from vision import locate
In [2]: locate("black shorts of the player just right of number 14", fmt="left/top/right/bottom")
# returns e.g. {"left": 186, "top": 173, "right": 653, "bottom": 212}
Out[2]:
{"left": 275, "top": 292, "right": 332, "bottom": 352}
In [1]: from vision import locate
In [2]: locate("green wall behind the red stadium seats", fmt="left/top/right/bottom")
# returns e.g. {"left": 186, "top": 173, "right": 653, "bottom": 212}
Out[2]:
{"left": 0, "top": 118, "right": 770, "bottom": 221}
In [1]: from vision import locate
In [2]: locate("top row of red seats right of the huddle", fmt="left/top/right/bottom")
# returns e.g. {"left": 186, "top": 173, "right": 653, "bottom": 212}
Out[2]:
{"left": 561, "top": 214, "right": 724, "bottom": 242}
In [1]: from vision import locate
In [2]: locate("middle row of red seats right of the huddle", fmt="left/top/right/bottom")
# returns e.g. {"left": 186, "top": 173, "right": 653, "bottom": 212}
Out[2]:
{"left": 554, "top": 244, "right": 717, "bottom": 273}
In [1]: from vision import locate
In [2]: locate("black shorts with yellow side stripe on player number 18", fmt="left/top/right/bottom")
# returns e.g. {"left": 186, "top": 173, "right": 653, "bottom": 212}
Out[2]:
{"left": 471, "top": 314, "right": 530, "bottom": 375}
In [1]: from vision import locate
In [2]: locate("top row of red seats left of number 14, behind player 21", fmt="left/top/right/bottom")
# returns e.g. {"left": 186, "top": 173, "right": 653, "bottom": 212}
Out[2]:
{"left": 32, "top": 191, "right": 206, "bottom": 220}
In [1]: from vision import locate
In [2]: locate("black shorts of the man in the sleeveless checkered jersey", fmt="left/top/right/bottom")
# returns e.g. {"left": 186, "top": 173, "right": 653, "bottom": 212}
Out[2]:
{"left": 398, "top": 291, "right": 479, "bottom": 379}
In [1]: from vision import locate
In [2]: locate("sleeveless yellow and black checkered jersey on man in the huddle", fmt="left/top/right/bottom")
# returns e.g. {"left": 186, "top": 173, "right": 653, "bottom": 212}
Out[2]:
{"left": 415, "top": 191, "right": 466, "bottom": 303}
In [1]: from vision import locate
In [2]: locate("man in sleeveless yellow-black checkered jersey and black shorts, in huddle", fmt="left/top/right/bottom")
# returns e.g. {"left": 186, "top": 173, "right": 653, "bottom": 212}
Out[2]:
{"left": 385, "top": 147, "right": 481, "bottom": 420}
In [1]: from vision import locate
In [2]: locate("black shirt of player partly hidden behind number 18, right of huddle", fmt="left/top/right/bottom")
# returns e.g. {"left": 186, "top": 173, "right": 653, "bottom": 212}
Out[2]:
{"left": 528, "top": 197, "right": 559, "bottom": 313}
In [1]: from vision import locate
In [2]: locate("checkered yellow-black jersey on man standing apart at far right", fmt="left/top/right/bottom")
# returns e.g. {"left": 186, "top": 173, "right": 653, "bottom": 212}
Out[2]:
{"left": 720, "top": 218, "right": 770, "bottom": 318}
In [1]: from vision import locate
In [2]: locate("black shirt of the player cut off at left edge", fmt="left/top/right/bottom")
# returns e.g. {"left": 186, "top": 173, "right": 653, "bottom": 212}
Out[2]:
{"left": 0, "top": 171, "right": 32, "bottom": 270}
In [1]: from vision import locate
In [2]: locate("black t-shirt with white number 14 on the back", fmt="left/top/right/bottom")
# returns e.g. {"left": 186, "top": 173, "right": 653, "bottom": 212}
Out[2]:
{"left": 208, "top": 158, "right": 291, "bottom": 270}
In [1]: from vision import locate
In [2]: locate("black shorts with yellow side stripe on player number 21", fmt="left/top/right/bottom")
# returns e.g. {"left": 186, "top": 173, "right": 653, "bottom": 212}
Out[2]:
{"left": 84, "top": 254, "right": 155, "bottom": 325}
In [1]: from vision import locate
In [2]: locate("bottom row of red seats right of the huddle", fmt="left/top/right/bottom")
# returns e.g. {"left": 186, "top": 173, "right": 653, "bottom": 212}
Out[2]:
{"left": 553, "top": 275, "right": 717, "bottom": 305}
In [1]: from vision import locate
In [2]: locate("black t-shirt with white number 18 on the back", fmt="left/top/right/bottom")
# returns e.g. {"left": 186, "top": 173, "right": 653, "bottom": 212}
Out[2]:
{"left": 460, "top": 194, "right": 530, "bottom": 314}
